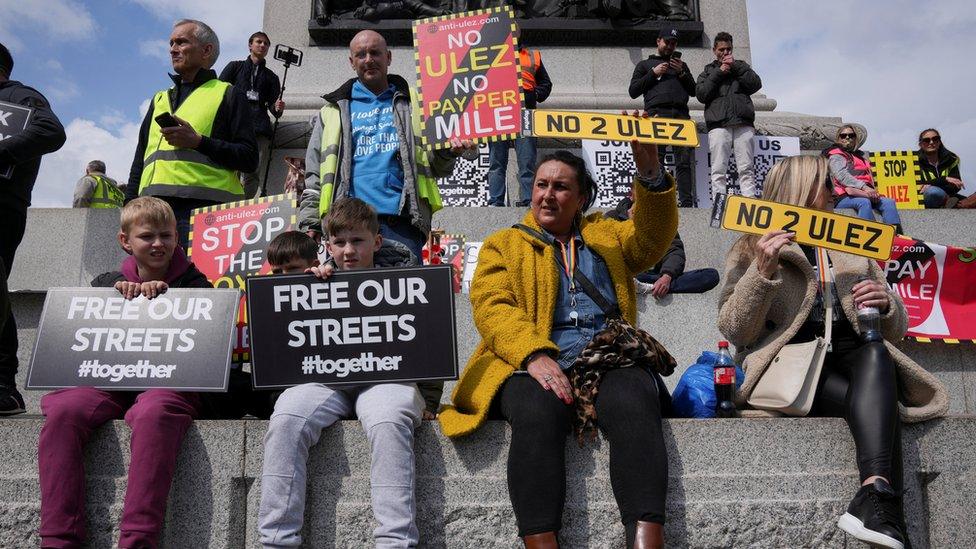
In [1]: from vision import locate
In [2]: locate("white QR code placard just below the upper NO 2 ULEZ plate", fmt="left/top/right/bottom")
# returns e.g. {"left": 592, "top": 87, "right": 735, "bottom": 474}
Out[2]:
{"left": 584, "top": 141, "right": 674, "bottom": 208}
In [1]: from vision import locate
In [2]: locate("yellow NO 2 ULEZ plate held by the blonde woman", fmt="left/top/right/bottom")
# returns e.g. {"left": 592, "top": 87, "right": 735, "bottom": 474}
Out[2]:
{"left": 722, "top": 195, "right": 895, "bottom": 260}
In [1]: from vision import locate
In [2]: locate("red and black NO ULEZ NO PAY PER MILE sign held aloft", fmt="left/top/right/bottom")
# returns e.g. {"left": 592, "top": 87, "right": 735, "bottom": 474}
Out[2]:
{"left": 413, "top": 7, "right": 522, "bottom": 149}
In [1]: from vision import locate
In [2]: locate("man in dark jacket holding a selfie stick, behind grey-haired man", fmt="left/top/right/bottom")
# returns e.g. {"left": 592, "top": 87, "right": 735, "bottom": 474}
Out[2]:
{"left": 220, "top": 31, "right": 285, "bottom": 198}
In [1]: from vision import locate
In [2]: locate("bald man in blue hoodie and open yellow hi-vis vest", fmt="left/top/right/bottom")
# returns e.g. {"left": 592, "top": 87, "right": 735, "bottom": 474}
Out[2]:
{"left": 299, "top": 30, "right": 474, "bottom": 261}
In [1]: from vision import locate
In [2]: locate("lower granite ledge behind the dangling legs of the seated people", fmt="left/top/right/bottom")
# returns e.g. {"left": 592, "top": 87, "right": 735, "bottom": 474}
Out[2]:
{"left": 0, "top": 416, "right": 976, "bottom": 548}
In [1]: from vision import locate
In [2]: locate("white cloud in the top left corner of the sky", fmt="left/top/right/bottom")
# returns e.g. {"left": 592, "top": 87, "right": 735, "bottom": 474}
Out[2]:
{"left": 0, "top": 0, "right": 97, "bottom": 51}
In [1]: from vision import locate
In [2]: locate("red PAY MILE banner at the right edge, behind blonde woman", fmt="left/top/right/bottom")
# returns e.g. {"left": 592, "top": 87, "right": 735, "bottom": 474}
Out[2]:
{"left": 878, "top": 236, "right": 976, "bottom": 341}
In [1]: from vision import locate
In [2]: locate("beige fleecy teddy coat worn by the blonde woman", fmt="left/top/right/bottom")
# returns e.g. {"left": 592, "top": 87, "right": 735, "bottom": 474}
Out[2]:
{"left": 718, "top": 244, "right": 949, "bottom": 422}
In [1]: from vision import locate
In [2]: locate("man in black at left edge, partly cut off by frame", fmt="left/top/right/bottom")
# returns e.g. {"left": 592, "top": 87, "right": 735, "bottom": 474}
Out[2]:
{"left": 0, "top": 44, "right": 65, "bottom": 416}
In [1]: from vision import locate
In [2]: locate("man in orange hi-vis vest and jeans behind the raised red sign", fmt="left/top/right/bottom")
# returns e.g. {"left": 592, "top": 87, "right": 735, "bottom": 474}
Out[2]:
{"left": 488, "top": 22, "right": 552, "bottom": 207}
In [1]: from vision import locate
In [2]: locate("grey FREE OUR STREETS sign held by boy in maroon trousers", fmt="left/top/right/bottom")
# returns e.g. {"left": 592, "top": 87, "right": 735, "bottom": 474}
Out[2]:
{"left": 27, "top": 288, "right": 240, "bottom": 391}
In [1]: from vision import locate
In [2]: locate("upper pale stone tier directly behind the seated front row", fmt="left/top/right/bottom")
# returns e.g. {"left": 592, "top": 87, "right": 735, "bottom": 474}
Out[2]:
{"left": 10, "top": 208, "right": 976, "bottom": 414}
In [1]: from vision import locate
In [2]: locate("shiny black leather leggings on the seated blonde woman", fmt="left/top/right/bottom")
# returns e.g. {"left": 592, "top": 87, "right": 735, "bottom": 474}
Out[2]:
{"left": 811, "top": 343, "right": 902, "bottom": 490}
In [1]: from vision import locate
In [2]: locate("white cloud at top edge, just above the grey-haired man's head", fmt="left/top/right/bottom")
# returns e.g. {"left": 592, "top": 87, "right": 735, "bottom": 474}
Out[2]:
{"left": 131, "top": 0, "right": 264, "bottom": 66}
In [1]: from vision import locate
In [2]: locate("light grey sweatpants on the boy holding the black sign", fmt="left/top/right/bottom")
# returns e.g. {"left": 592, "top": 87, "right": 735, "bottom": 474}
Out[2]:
{"left": 258, "top": 383, "right": 424, "bottom": 549}
